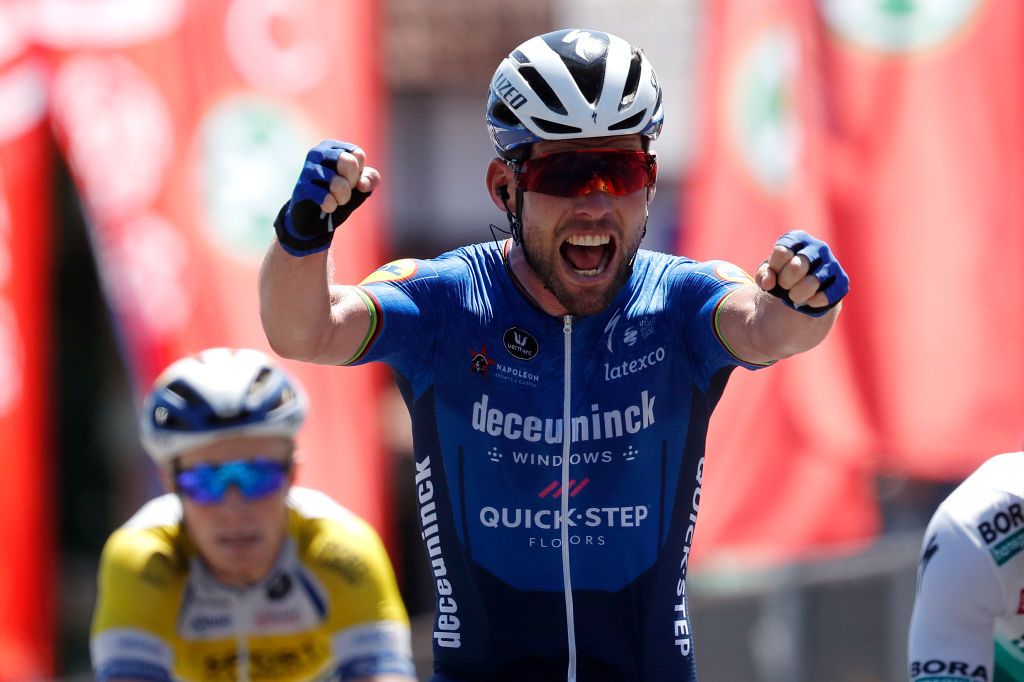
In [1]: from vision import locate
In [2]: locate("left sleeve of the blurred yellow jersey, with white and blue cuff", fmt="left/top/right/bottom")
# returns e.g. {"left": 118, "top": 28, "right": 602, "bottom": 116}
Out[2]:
{"left": 89, "top": 528, "right": 182, "bottom": 681}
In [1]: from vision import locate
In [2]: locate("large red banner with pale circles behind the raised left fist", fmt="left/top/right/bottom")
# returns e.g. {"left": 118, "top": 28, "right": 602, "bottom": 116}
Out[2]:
{"left": 41, "top": 0, "right": 389, "bottom": 535}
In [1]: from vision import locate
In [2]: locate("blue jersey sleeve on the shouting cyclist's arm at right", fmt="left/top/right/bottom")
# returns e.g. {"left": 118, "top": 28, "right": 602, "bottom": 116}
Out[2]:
{"left": 671, "top": 260, "right": 766, "bottom": 388}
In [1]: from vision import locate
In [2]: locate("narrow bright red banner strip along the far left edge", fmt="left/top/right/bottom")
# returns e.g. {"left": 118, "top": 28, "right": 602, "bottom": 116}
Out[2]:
{"left": 0, "top": 51, "right": 56, "bottom": 680}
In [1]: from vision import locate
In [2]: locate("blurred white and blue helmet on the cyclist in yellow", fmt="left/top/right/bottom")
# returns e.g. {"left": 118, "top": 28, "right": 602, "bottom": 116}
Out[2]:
{"left": 139, "top": 348, "right": 307, "bottom": 464}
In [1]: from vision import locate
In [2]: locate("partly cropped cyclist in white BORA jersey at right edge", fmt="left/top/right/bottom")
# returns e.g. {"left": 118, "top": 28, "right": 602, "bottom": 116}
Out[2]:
{"left": 908, "top": 453, "right": 1024, "bottom": 682}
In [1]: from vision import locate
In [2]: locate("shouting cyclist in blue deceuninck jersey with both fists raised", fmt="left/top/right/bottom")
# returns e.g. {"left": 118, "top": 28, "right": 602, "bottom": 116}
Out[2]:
{"left": 260, "top": 30, "right": 849, "bottom": 682}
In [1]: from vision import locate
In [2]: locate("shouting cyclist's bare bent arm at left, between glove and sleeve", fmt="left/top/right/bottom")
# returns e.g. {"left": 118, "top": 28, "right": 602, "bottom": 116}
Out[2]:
{"left": 259, "top": 244, "right": 370, "bottom": 365}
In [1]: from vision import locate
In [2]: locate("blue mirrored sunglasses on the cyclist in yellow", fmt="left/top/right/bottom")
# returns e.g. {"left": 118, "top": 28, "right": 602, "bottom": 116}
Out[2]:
{"left": 174, "top": 458, "right": 292, "bottom": 505}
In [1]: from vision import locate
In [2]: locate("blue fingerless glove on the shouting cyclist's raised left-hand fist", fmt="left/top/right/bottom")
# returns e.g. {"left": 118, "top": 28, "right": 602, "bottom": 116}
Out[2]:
{"left": 273, "top": 139, "right": 372, "bottom": 256}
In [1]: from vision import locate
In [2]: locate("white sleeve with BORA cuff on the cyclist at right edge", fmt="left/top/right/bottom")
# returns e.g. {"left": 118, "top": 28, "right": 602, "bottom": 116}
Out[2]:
{"left": 907, "top": 507, "right": 1004, "bottom": 682}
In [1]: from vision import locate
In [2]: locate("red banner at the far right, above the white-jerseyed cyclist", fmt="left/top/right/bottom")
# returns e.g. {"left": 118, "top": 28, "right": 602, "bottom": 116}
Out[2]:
{"left": 817, "top": 0, "right": 1024, "bottom": 479}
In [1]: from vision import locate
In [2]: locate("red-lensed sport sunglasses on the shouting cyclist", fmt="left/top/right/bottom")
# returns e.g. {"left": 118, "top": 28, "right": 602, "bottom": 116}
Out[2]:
{"left": 517, "top": 147, "right": 657, "bottom": 197}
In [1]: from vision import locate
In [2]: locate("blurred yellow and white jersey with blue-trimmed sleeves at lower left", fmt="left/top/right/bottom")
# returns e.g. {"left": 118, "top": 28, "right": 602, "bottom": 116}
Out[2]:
{"left": 90, "top": 487, "right": 414, "bottom": 681}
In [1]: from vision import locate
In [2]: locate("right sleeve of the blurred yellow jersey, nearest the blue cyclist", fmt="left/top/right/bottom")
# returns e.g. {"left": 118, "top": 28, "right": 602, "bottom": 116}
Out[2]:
{"left": 305, "top": 516, "right": 415, "bottom": 680}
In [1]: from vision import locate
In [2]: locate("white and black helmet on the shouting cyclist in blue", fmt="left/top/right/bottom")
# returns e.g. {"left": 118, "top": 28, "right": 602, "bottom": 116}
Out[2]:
{"left": 487, "top": 29, "right": 665, "bottom": 159}
